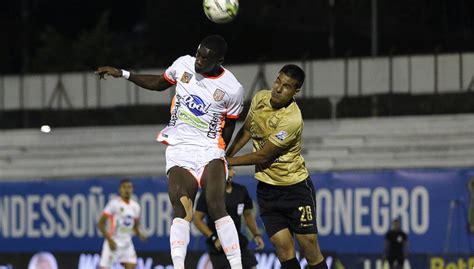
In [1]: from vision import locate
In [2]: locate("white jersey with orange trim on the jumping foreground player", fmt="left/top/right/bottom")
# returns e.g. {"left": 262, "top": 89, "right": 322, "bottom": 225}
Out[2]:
{"left": 157, "top": 55, "right": 244, "bottom": 149}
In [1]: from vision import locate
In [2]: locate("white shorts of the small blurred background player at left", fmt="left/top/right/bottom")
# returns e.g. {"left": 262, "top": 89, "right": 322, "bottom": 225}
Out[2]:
{"left": 99, "top": 240, "right": 137, "bottom": 268}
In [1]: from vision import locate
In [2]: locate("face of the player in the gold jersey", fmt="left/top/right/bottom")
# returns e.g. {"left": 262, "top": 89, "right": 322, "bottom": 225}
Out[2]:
{"left": 271, "top": 72, "right": 299, "bottom": 108}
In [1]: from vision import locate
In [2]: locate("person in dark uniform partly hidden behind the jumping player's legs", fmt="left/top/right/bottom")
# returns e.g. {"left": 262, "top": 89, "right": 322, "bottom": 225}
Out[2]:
{"left": 194, "top": 170, "right": 264, "bottom": 269}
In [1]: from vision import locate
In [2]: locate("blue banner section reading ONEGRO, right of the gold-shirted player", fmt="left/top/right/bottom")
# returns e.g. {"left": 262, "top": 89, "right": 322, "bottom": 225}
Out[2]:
{"left": 312, "top": 169, "right": 474, "bottom": 253}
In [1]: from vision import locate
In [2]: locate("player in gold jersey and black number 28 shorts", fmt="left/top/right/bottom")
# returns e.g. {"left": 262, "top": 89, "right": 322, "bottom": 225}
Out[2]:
{"left": 227, "top": 65, "right": 328, "bottom": 269}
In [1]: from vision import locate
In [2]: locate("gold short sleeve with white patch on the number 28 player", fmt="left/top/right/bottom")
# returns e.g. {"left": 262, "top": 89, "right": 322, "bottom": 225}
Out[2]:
{"left": 268, "top": 118, "right": 303, "bottom": 148}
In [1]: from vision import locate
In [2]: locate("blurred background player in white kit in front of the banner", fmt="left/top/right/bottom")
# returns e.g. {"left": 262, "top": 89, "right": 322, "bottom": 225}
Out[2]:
{"left": 97, "top": 179, "right": 146, "bottom": 269}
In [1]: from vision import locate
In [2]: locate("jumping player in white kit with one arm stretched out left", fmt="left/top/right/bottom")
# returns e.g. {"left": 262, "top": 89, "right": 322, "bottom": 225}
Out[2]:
{"left": 96, "top": 35, "right": 244, "bottom": 269}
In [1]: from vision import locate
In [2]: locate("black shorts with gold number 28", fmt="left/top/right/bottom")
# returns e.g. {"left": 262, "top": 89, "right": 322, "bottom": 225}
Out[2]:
{"left": 257, "top": 178, "right": 318, "bottom": 237}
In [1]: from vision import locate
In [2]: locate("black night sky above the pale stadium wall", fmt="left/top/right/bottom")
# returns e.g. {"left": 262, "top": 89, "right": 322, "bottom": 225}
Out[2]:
{"left": 0, "top": 0, "right": 474, "bottom": 73}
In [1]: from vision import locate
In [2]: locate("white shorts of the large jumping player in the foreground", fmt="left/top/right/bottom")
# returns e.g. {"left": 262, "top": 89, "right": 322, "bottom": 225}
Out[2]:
{"left": 166, "top": 146, "right": 227, "bottom": 185}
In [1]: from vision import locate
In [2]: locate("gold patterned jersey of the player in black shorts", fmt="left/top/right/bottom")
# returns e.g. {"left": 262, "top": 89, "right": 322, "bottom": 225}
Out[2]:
{"left": 247, "top": 90, "right": 309, "bottom": 186}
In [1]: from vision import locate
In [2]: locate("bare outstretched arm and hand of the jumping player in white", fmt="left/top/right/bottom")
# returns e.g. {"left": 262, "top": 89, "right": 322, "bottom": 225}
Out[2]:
{"left": 95, "top": 66, "right": 173, "bottom": 92}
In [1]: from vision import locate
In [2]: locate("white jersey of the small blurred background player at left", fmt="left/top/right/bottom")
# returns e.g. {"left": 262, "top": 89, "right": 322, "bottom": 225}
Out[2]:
{"left": 103, "top": 197, "right": 140, "bottom": 247}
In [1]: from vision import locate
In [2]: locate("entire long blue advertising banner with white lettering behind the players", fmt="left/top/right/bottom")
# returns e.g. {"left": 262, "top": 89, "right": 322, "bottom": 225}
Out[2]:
{"left": 0, "top": 169, "right": 474, "bottom": 254}
